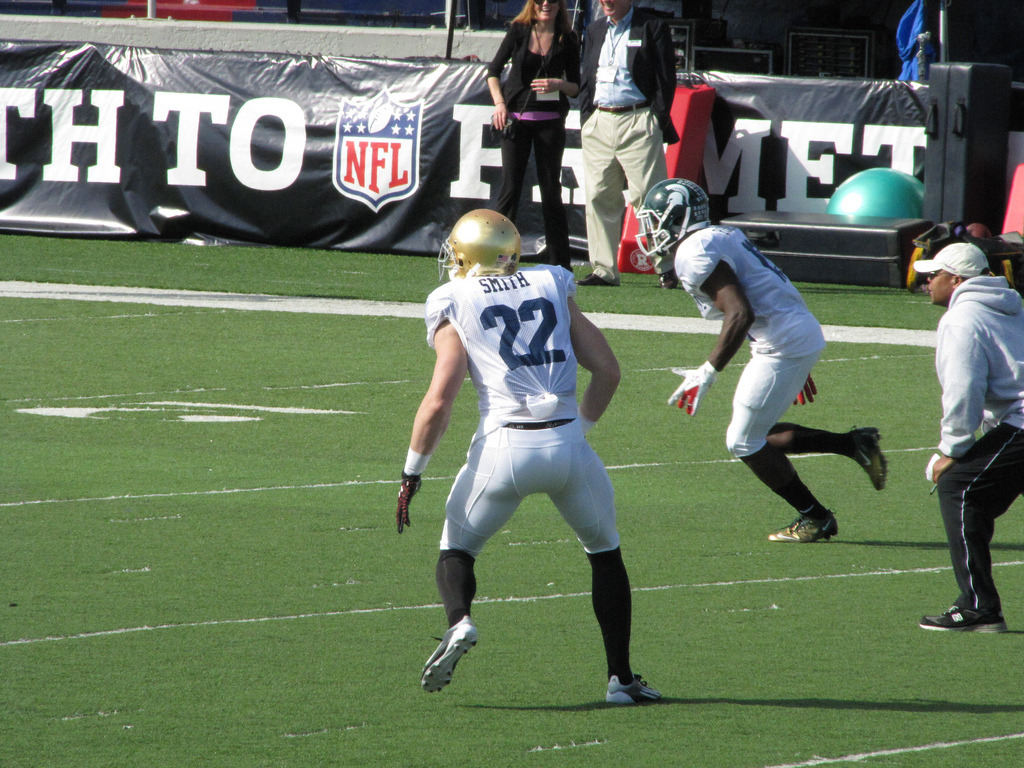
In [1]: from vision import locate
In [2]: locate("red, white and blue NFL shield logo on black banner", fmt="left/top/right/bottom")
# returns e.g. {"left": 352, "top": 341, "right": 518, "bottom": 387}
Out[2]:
{"left": 333, "top": 89, "right": 423, "bottom": 213}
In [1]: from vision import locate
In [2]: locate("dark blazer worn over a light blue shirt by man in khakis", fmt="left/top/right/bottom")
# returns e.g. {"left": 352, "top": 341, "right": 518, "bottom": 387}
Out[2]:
{"left": 580, "top": 5, "right": 679, "bottom": 144}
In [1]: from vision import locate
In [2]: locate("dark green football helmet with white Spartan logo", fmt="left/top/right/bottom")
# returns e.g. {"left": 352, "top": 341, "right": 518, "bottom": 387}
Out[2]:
{"left": 637, "top": 178, "right": 711, "bottom": 256}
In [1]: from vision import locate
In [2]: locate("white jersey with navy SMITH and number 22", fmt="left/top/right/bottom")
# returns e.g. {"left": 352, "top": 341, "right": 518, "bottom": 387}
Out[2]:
{"left": 426, "top": 265, "right": 579, "bottom": 436}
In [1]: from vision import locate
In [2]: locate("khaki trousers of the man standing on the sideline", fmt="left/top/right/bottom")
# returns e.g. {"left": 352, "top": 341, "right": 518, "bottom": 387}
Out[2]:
{"left": 580, "top": 108, "right": 671, "bottom": 285}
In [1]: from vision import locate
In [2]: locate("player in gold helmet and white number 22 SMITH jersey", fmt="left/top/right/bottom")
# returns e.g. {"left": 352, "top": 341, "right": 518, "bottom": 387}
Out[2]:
{"left": 397, "top": 209, "right": 662, "bottom": 703}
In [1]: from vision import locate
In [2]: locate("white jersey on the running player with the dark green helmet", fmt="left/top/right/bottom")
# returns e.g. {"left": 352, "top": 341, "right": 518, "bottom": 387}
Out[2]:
{"left": 675, "top": 225, "right": 825, "bottom": 356}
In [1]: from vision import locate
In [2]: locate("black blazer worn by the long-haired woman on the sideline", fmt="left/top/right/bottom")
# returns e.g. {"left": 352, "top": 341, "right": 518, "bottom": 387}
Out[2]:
{"left": 487, "top": 24, "right": 580, "bottom": 117}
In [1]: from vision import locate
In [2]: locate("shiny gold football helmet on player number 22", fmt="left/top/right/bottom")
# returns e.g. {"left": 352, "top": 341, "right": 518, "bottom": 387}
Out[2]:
{"left": 437, "top": 208, "right": 522, "bottom": 280}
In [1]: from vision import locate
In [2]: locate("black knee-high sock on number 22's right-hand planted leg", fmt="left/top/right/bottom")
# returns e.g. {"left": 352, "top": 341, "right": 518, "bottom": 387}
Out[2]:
{"left": 587, "top": 548, "right": 633, "bottom": 684}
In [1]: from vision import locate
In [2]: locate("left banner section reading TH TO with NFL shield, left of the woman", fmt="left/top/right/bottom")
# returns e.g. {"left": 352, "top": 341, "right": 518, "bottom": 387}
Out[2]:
{"left": 0, "top": 44, "right": 500, "bottom": 253}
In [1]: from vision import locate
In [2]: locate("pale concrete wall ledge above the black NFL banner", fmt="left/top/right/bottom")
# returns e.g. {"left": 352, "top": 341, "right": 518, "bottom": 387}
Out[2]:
{"left": 0, "top": 14, "right": 504, "bottom": 61}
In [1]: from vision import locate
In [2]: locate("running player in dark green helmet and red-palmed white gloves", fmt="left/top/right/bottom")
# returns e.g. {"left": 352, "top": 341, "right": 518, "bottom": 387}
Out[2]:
{"left": 637, "top": 179, "right": 887, "bottom": 543}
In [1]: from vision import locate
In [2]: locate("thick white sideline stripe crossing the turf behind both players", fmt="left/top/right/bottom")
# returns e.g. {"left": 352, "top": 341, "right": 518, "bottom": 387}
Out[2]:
{"left": 0, "top": 281, "right": 935, "bottom": 347}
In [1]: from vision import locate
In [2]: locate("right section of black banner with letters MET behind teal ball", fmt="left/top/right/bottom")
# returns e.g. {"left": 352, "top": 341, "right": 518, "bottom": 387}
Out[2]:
{"left": 703, "top": 73, "right": 928, "bottom": 218}
